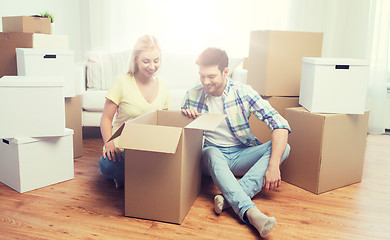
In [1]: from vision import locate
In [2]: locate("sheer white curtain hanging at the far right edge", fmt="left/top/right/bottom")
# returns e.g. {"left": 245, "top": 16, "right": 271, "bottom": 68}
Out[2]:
{"left": 367, "top": 0, "right": 390, "bottom": 134}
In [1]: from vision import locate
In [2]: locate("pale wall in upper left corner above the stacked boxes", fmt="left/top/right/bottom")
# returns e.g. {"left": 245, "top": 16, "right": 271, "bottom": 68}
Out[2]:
{"left": 0, "top": 0, "right": 84, "bottom": 61}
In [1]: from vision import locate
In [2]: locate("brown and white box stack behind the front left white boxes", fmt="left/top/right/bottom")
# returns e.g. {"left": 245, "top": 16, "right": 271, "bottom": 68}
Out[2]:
{"left": 0, "top": 16, "right": 83, "bottom": 158}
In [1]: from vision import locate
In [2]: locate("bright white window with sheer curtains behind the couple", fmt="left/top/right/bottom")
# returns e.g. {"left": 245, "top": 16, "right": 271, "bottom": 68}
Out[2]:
{"left": 83, "top": 0, "right": 290, "bottom": 57}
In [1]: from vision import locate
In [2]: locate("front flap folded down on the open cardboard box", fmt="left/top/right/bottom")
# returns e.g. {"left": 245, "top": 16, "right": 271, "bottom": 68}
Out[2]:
{"left": 113, "top": 123, "right": 182, "bottom": 153}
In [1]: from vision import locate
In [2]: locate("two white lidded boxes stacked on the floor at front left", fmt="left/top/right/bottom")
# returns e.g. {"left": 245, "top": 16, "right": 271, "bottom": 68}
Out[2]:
{"left": 0, "top": 76, "right": 74, "bottom": 193}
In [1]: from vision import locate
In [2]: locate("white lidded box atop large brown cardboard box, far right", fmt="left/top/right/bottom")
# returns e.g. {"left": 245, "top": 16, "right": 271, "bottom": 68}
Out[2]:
{"left": 281, "top": 58, "right": 369, "bottom": 194}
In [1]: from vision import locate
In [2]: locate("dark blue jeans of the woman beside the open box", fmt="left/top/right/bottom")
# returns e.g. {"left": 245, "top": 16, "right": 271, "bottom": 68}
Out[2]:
{"left": 99, "top": 152, "right": 125, "bottom": 183}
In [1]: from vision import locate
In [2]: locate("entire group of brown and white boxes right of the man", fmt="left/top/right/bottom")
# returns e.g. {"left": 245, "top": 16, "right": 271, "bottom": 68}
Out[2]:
{"left": 247, "top": 31, "right": 368, "bottom": 194}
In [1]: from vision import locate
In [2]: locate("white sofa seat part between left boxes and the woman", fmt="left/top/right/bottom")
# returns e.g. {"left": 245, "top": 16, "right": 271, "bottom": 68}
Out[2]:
{"left": 83, "top": 90, "right": 107, "bottom": 112}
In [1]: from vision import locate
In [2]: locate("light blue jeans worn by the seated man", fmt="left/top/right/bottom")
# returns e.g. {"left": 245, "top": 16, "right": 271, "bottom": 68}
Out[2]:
{"left": 202, "top": 141, "right": 290, "bottom": 221}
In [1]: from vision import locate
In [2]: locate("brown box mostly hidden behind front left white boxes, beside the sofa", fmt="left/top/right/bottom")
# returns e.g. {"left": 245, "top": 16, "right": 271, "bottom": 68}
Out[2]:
{"left": 65, "top": 95, "right": 83, "bottom": 158}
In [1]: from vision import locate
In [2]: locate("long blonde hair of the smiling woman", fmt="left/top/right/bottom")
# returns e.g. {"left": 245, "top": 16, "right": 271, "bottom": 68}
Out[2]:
{"left": 128, "top": 34, "right": 161, "bottom": 76}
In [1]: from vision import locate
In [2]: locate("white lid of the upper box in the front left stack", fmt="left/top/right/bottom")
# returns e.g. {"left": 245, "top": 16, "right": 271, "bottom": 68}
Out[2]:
{"left": 0, "top": 76, "right": 65, "bottom": 87}
